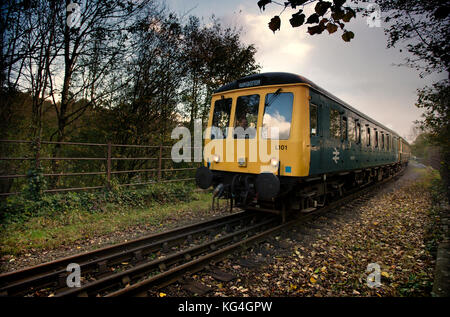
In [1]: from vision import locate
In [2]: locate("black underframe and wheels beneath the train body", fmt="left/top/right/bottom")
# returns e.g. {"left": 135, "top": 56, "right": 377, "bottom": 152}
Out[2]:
{"left": 207, "top": 162, "right": 408, "bottom": 221}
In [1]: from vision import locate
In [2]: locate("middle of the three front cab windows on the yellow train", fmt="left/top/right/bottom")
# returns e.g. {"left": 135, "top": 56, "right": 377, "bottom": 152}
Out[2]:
{"left": 233, "top": 95, "right": 259, "bottom": 139}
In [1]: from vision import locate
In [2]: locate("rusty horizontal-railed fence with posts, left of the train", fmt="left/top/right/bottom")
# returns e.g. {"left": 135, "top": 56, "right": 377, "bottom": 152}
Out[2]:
{"left": 0, "top": 140, "right": 201, "bottom": 197}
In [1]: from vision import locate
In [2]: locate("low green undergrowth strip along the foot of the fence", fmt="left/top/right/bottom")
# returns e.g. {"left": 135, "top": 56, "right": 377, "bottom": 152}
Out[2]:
{"left": 0, "top": 183, "right": 194, "bottom": 224}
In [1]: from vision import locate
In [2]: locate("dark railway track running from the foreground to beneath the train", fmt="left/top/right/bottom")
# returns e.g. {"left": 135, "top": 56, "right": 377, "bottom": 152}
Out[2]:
{"left": 0, "top": 171, "right": 403, "bottom": 297}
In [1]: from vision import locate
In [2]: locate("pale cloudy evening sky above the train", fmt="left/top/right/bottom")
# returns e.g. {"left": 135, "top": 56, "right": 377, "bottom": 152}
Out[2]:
{"left": 164, "top": 0, "right": 444, "bottom": 142}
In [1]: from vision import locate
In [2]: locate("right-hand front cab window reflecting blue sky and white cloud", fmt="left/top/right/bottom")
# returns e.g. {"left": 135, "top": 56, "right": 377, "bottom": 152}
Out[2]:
{"left": 262, "top": 92, "right": 294, "bottom": 140}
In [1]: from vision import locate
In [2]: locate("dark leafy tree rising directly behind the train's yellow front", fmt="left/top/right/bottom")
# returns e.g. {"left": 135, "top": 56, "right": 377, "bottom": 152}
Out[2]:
{"left": 181, "top": 16, "right": 259, "bottom": 131}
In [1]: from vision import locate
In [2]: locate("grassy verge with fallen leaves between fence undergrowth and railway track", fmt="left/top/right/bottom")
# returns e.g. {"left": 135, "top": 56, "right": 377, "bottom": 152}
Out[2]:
{"left": 0, "top": 192, "right": 211, "bottom": 255}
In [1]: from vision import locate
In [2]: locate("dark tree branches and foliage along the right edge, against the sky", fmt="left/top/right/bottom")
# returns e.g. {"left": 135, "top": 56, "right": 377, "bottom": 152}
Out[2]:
{"left": 376, "top": 0, "right": 450, "bottom": 201}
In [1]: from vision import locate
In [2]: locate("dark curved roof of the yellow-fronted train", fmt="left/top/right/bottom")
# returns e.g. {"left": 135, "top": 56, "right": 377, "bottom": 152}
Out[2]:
{"left": 214, "top": 72, "right": 403, "bottom": 139}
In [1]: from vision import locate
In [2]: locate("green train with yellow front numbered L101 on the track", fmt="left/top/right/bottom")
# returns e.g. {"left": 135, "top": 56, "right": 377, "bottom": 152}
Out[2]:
{"left": 195, "top": 72, "right": 411, "bottom": 216}
